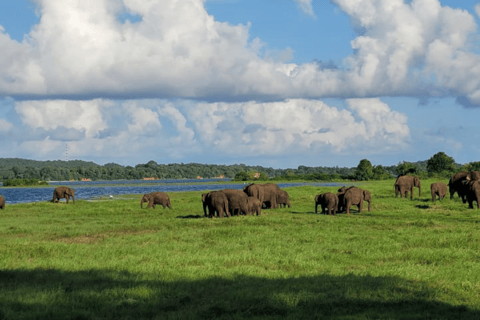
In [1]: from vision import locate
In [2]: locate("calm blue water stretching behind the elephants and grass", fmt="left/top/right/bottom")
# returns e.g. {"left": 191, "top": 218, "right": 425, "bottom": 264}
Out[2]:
{"left": 0, "top": 179, "right": 339, "bottom": 204}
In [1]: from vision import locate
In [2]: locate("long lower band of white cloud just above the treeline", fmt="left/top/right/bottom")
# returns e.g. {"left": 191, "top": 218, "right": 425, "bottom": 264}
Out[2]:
{"left": 11, "top": 99, "right": 410, "bottom": 163}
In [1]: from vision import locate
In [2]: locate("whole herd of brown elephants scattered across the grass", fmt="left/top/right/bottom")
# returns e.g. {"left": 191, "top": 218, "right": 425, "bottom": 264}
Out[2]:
{"left": 0, "top": 171, "right": 480, "bottom": 212}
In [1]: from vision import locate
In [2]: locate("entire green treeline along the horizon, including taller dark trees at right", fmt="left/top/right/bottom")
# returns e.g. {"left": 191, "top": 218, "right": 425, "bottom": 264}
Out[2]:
{"left": 0, "top": 152, "right": 480, "bottom": 181}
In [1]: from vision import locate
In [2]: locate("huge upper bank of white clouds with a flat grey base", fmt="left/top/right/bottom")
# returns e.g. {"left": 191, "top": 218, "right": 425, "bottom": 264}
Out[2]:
{"left": 0, "top": 0, "right": 480, "bottom": 103}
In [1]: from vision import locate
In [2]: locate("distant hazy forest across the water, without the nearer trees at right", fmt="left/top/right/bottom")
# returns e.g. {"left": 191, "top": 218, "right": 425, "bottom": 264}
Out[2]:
{"left": 0, "top": 158, "right": 412, "bottom": 181}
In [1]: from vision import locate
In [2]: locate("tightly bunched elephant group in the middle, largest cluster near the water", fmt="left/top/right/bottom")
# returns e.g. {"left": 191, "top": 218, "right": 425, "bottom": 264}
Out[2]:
{"left": 202, "top": 183, "right": 290, "bottom": 218}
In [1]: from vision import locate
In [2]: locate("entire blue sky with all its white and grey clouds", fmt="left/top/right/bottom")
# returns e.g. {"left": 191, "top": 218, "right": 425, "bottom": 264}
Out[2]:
{"left": 0, "top": 0, "right": 480, "bottom": 168}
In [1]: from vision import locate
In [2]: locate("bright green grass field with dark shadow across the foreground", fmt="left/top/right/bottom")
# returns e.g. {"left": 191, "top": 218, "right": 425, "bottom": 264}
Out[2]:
{"left": 0, "top": 180, "right": 480, "bottom": 319}
